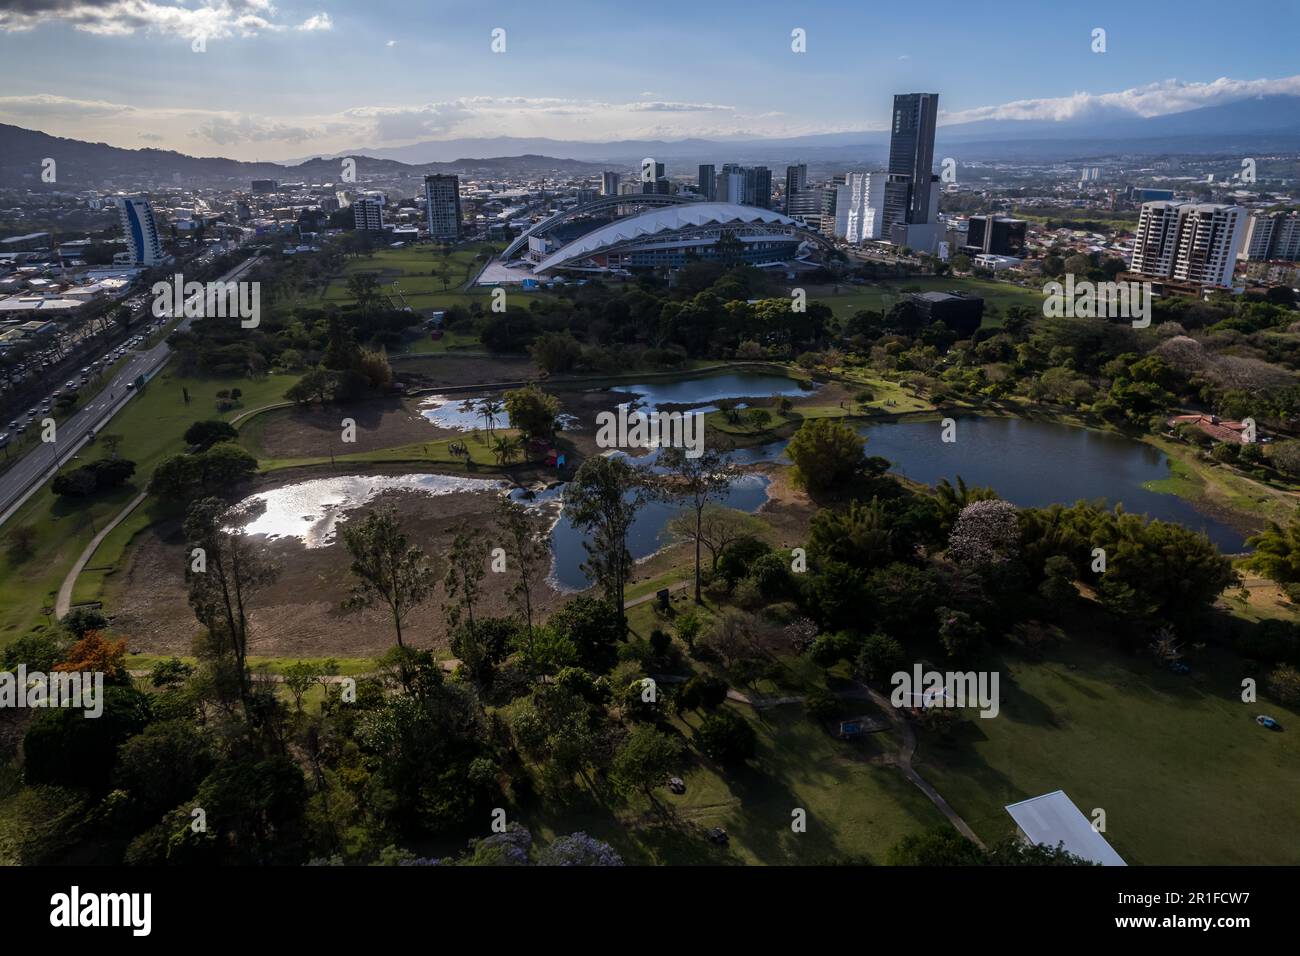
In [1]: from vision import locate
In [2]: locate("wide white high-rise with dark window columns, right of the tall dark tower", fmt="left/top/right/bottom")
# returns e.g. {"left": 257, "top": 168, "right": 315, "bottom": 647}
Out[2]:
{"left": 1130, "top": 202, "right": 1245, "bottom": 287}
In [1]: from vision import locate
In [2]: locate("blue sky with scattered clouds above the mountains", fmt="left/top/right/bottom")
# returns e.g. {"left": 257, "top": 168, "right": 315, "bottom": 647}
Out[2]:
{"left": 0, "top": 0, "right": 1300, "bottom": 160}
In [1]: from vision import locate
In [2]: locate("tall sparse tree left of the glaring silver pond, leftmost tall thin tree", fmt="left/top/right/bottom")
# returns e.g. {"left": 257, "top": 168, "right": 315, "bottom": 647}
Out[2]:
{"left": 183, "top": 498, "right": 277, "bottom": 709}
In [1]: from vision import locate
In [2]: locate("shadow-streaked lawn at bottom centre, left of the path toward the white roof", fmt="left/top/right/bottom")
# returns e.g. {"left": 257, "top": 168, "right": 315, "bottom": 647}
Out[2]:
{"left": 521, "top": 704, "right": 943, "bottom": 865}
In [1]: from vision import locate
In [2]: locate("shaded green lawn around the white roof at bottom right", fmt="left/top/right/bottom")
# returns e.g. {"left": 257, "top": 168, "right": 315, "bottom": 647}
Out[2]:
{"left": 915, "top": 639, "right": 1300, "bottom": 865}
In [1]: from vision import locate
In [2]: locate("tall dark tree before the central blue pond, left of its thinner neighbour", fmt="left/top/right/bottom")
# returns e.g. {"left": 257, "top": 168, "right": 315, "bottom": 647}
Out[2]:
{"left": 564, "top": 455, "right": 646, "bottom": 631}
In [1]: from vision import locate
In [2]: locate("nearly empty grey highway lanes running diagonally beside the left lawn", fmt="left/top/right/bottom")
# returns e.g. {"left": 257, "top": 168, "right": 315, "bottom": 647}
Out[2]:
{"left": 0, "top": 256, "right": 259, "bottom": 525}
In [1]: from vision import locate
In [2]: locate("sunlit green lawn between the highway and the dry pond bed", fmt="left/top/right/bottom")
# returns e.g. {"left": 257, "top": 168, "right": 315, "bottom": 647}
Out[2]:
{"left": 0, "top": 368, "right": 296, "bottom": 644}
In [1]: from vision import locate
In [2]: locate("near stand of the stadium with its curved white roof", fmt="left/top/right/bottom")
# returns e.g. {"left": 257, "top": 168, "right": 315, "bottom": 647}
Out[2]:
{"left": 521, "top": 202, "right": 813, "bottom": 276}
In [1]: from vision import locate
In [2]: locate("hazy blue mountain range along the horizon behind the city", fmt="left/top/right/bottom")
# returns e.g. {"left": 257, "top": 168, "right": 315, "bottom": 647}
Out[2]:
{"left": 0, "top": 95, "right": 1300, "bottom": 189}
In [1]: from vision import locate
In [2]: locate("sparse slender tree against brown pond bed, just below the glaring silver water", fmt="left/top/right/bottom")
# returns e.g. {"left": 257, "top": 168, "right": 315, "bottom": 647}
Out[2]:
{"left": 343, "top": 505, "right": 438, "bottom": 648}
